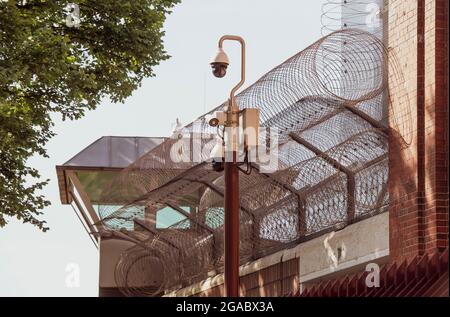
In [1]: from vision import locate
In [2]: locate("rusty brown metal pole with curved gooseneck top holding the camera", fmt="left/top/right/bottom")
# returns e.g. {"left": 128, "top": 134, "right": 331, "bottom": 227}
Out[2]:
{"left": 219, "top": 35, "right": 245, "bottom": 297}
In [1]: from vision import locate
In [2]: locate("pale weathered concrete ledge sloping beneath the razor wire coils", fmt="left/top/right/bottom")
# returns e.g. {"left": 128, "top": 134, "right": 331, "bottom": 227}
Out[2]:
{"left": 165, "top": 212, "right": 389, "bottom": 297}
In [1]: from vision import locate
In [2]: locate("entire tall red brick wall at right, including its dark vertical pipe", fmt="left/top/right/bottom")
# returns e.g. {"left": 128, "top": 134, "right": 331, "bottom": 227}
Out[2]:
{"left": 387, "top": 0, "right": 448, "bottom": 259}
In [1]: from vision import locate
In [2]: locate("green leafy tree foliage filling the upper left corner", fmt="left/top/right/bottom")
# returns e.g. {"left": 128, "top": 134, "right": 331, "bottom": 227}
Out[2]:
{"left": 0, "top": 0, "right": 179, "bottom": 231}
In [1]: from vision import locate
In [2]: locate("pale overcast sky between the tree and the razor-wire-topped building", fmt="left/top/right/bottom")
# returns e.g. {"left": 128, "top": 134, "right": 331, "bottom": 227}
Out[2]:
{"left": 0, "top": 0, "right": 324, "bottom": 296}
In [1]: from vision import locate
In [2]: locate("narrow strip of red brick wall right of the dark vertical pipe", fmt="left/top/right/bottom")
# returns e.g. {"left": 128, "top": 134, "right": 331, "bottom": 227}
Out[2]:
{"left": 423, "top": 0, "right": 449, "bottom": 252}
